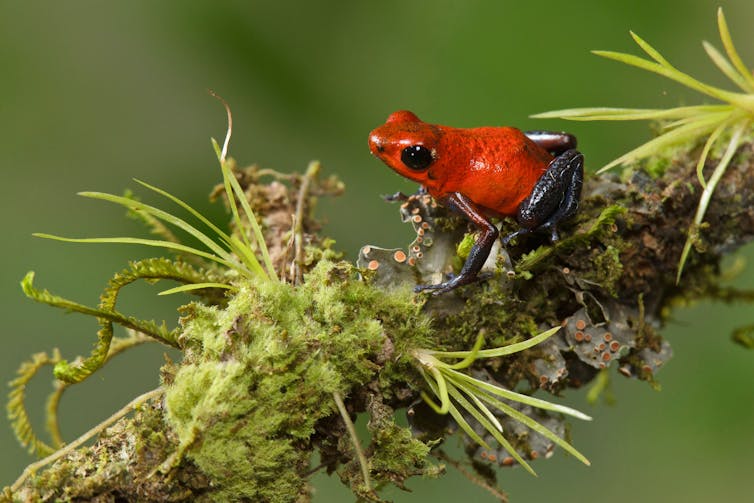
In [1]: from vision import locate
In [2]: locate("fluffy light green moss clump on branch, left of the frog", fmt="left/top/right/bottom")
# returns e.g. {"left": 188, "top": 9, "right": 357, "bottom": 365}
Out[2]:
{"left": 165, "top": 261, "right": 430, "bottom": 501}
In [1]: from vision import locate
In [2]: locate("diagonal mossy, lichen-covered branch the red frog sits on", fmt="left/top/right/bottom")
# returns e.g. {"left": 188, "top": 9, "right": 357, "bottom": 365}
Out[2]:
{"left": 5, "top": 136, "right": 754, "bottom": 501}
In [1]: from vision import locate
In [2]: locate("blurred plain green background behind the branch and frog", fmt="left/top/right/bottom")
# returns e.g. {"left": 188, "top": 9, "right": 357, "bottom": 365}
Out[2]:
{"left": 0, "top": 0, "right": 754, "bottom": 503}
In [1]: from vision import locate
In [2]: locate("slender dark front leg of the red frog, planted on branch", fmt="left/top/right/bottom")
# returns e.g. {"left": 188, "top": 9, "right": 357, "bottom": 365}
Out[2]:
{"left": 414, "top": 192, "right": 499, "bottom": 295}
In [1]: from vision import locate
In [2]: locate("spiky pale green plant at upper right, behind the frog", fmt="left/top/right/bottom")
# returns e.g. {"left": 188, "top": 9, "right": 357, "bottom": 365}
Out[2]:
{"left": 533, "top": 8, "right": 754, "bottom": 283}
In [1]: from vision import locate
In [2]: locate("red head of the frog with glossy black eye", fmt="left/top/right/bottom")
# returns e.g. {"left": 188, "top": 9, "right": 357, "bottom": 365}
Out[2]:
{"left": 369, "top": 110, "right": 441, "bottom": 185}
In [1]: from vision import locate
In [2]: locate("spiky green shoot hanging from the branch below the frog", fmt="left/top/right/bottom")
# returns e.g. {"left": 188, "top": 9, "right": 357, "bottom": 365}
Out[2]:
{"left": 413, "top": 327, "right": 592, "bottom": 476}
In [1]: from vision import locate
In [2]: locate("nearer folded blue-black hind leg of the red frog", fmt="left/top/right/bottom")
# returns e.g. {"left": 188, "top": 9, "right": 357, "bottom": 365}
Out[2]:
{"left": 502, "top": 149, "right": 584, "bottom": 246}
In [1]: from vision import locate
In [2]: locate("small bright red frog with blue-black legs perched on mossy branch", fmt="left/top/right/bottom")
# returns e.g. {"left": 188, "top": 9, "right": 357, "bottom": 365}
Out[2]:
{"left": 369, "top": 111, "right": 584, "bottom": 293}
